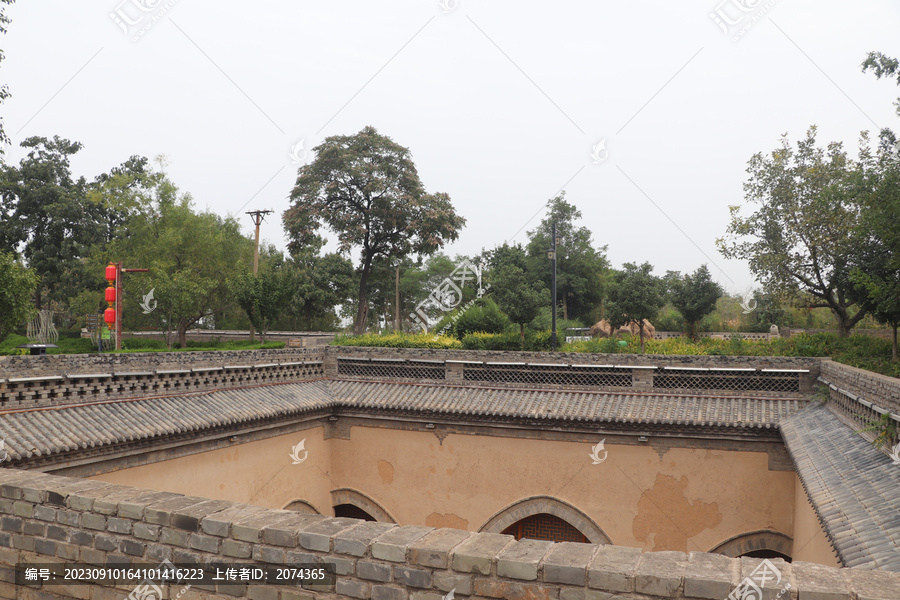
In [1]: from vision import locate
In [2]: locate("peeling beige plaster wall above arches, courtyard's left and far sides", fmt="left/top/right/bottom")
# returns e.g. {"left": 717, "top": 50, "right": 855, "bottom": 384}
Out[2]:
{"left": 89, "top": 426, "right": 811, "bottom": 560}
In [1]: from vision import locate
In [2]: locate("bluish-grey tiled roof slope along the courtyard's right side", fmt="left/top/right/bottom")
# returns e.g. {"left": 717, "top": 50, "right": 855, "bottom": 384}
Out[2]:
{"left": 781, "top": 405, "right": 900, "bottom": 571}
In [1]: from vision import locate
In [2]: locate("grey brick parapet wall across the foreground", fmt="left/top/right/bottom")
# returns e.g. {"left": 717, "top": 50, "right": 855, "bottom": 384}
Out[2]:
{"left": 0, "top": 469, "right": 900, "bottom": 600}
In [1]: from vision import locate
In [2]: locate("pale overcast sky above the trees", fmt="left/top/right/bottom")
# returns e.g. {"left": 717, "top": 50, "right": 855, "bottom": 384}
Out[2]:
{"left": 0, "top": 0, "right": 900, "bottom": 293}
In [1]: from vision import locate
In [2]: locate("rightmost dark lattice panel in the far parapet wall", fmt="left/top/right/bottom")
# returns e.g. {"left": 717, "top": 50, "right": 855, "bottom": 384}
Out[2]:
{"left": 653, "top": 368, "right": 800, "bottom": 392}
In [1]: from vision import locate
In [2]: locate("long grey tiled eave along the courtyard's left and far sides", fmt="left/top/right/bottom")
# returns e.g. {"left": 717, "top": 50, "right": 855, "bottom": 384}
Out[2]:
{"left": 0, "top": 380, "right": 806, "bottom": 459}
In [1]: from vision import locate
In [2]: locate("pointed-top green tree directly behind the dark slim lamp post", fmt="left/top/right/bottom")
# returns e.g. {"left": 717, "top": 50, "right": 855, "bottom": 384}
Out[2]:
{"left": 527, "top": 193, "right": 609, "bottom": 320}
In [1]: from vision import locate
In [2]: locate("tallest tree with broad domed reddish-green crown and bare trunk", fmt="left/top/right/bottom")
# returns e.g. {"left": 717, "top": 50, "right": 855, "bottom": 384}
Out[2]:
{"left": 284, "top": 127, "right": 465, "bottom": 334}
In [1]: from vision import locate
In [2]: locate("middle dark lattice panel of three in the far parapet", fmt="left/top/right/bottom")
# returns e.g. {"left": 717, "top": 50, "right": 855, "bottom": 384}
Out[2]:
{"left": 463, "top": 364, "right": 633, "bottom": 387}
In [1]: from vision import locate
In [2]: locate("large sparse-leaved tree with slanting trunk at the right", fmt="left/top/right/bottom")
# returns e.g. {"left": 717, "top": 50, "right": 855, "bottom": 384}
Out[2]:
{"left": 717, "top": 127, "right": 871, "bottom": 337}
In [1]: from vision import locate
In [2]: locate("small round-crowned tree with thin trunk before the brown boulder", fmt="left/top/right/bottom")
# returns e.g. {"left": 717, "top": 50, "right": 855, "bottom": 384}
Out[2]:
{"left": 606, "top": 262, "right": 665, "bottom": 353}
